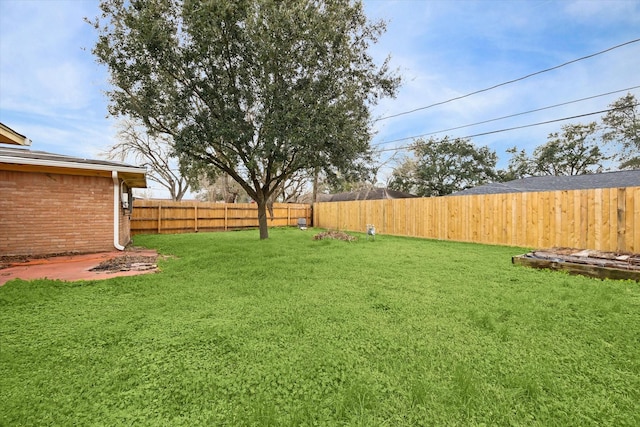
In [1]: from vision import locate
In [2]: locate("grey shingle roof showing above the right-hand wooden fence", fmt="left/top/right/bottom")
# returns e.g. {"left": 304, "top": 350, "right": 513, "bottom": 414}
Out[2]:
{"left": 452, "top": 169, "right": 640, "bottom": 196}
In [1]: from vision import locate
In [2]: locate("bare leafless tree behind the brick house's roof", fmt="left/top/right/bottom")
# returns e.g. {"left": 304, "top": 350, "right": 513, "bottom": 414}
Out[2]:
{"left": 106, "top": 120, "right": 198, "bottom": 201}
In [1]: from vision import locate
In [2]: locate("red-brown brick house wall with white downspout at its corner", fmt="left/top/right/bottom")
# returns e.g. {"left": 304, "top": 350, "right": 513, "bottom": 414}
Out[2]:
{"left": 0, "top": 170, "right": 129, "bottom": 255}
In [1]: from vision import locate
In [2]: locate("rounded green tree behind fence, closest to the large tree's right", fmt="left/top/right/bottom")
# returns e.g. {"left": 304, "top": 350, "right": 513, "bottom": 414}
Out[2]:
{"left": 390, "top": 136, "right": 498, "bottom": 197}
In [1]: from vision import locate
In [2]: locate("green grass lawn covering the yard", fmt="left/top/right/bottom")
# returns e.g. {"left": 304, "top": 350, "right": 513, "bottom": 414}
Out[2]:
{"left": 0, "top": 229, "right": 640, "bottom": 426}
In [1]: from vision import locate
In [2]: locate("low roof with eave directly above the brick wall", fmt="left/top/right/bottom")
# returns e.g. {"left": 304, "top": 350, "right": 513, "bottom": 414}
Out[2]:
{"left": 0, "top": 147, "right": 147, "bottom": 188}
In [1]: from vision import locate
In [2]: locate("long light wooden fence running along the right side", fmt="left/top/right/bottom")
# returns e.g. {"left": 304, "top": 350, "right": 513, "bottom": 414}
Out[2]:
{"left": 313, "top": 187, "right": 640, "bottom": 252}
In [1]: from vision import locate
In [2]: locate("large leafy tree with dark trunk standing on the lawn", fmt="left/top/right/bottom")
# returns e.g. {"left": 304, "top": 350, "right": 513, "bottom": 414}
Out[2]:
{"left": 92, "top": 0, "right": 399, "bottom": 238}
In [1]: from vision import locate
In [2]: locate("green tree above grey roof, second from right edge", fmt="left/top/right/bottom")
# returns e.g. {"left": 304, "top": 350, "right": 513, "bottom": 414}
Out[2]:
{"left": 532, "top": 122, "right": 608, "bottom": 175}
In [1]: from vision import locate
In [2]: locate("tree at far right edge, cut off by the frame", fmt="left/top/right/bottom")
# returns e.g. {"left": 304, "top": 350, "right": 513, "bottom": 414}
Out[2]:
{"left": 602, "top": 93, "right": 640, "bottom": 169}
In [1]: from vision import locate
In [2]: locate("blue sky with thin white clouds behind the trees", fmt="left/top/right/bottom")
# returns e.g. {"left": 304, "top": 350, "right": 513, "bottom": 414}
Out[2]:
{"left": 0, "top": 0, "right": 640, "bottom": 196}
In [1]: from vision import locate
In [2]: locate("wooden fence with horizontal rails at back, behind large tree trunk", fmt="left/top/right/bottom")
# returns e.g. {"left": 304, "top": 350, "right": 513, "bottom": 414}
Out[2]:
{"left": 131, "top": 200, "right": 311, "bottom": 235}
